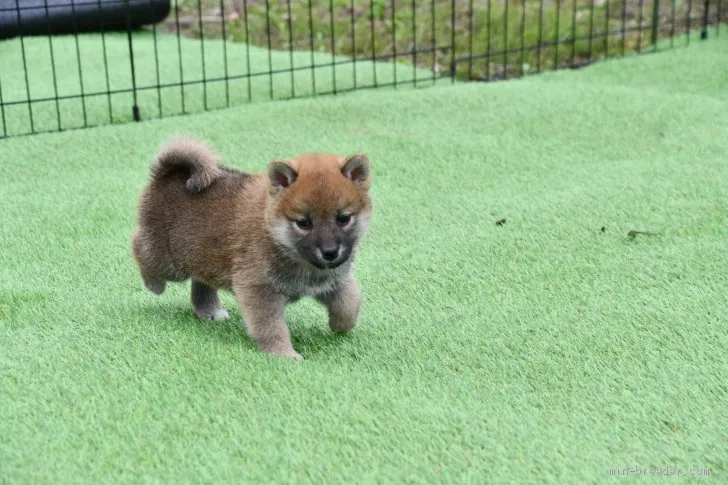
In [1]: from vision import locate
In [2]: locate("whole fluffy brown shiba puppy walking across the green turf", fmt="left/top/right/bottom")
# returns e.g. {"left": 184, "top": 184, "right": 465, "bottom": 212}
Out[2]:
{"left": 132, "top": 138, "right": 372, "bottom": 360}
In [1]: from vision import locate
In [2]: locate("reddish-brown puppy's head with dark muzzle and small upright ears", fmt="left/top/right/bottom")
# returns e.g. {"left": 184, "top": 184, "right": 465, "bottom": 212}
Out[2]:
{"left": 268, "top": 154, "right": 372, "bottom": 269}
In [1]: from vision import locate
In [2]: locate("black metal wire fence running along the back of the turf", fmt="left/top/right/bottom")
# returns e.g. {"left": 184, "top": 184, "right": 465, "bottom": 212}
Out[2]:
{"left": 0, "top": 0, "right": 722, "bottom": 138}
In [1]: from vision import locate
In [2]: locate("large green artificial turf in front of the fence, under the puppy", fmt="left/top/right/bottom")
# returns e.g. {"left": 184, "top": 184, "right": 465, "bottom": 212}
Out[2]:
{"left": 0, "top": 32, "right": 728, "bottom": 484}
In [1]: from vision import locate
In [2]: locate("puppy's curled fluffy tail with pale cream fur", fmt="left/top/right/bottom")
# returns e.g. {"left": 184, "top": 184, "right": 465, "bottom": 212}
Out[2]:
{"left": 152, "top": 138, "right": 222, "bottom": 194}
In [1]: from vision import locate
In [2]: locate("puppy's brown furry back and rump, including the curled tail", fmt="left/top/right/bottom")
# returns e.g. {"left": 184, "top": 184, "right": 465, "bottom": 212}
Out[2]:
{"left": 135, "top": 139, "right": 263, "bottom": 287}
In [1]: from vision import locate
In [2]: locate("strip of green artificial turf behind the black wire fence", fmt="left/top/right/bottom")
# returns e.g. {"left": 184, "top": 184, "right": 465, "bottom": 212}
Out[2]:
{"left": 0, "top": 31, "right": 445, "bottom": 136}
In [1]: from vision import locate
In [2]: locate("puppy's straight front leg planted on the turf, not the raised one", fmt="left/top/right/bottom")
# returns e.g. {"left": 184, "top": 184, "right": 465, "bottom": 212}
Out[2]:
{"left": 234, "top": 285, "right": 303, "bottom": 361}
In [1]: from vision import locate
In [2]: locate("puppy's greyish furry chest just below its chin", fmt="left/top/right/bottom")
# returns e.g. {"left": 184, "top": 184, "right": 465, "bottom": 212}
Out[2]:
{"left": 267, "top": 264, "right": 346, "bottom": 300}
